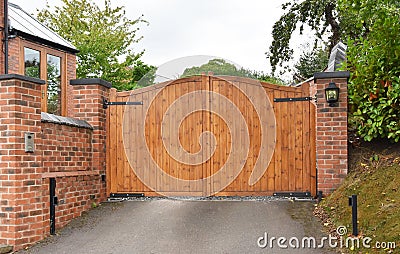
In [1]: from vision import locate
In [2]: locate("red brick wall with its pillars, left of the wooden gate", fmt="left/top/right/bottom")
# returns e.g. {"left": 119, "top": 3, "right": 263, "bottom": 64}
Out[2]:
{"left": 0, "top": 74, "right": 109, "bottom": 250}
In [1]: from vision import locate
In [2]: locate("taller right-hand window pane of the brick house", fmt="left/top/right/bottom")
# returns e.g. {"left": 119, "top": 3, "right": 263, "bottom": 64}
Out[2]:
{"left": 47, "top": 55, "right": 61, "bottom": 115}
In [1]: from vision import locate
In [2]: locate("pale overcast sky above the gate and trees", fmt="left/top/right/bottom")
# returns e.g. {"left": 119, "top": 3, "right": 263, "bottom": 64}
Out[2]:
{"left": 10, "top": 0, "right": 307, "bottom": 80}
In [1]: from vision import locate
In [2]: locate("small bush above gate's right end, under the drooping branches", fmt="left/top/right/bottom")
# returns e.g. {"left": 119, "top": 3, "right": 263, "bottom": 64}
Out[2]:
{"left": 293, "top": 48, "right": 329, "bottom": 83}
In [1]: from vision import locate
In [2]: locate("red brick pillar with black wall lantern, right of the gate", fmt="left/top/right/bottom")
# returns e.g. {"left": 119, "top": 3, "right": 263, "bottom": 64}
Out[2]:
{"left": 311, "top": 72, "right": 350, "bottom": 194}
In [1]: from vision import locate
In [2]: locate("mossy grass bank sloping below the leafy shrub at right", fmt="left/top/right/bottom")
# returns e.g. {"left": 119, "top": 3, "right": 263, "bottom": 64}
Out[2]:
{"left": 319, "top": 140, "right": 400, "bottom": 253}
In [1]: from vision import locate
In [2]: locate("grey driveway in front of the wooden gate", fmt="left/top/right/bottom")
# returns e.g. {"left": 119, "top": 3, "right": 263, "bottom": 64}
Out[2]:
{"left": 19, "top": 198, "right": 335, "bottom": 254}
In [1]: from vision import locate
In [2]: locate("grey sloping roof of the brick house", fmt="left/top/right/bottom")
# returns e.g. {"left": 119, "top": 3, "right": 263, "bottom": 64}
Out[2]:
{"left": 8, "top": 3, "right": 78, "bottom": 53}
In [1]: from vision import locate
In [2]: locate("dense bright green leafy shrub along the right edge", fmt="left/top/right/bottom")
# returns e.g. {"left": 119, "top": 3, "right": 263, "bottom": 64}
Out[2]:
{"left": 340, "top": 0, "right": 400, "bottom": 142}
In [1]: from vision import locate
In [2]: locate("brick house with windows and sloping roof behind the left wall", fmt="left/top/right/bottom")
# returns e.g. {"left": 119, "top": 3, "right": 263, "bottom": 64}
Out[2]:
{"left": 0, "top": 0, "right": 78, "bottom": 116}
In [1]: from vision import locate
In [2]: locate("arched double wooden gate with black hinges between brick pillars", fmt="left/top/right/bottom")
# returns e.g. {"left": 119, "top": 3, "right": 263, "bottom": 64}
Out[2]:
{"left": 107, "top": 76, "right": 316, "bottom": 196}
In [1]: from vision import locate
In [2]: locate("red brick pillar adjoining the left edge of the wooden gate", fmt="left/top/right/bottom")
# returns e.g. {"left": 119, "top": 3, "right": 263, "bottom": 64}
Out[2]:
{"left": 70, "top": 79, "right": 111, "bottom": 200}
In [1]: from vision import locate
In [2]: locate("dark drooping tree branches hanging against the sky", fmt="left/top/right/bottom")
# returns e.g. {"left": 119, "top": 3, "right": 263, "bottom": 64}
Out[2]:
{"left": 267, "top": 0, "right": 341, "bottom": 72}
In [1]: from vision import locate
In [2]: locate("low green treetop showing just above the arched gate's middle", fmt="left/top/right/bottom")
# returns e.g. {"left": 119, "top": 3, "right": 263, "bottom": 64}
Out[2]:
{"left": 181, "top": 59, "right": 284, "bottom": 85}
